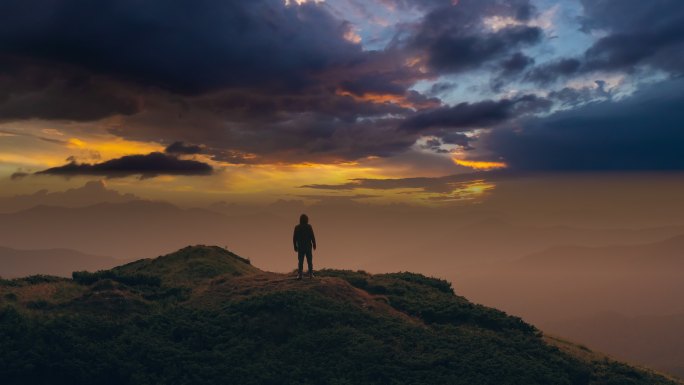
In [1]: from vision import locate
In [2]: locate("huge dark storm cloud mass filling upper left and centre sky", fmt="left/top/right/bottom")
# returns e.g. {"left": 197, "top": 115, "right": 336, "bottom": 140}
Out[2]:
{"left": 0, "top": 0, "right": 556, "bottom": 165}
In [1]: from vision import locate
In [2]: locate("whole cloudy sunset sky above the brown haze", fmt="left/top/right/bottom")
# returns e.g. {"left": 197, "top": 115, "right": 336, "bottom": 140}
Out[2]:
{"left": 0, "top": 0, "right": 684, "bottom": 206}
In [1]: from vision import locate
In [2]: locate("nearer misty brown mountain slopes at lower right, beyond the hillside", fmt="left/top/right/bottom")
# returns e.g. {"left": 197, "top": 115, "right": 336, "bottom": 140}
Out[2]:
{"left": 455, "top": 236, "right": 684, "bottom": 376}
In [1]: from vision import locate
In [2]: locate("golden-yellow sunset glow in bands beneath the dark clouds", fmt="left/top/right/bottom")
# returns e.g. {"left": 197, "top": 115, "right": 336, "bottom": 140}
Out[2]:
{"left": 0, "top": 122, "right": 500, "bottom": 206}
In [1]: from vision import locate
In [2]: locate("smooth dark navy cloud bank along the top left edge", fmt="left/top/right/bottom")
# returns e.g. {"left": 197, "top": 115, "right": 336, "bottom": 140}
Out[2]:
{"left": 0, "top": 0, "right": 360, "bottom": 93}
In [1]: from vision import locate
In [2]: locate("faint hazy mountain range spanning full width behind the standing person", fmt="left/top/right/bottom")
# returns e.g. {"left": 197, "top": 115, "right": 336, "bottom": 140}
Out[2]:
{"left": 5, "top": 195, "right": 684, "bottom": 274}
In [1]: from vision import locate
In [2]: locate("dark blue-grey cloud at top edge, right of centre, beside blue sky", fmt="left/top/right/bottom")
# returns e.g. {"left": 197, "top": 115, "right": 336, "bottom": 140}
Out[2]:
{"left": 409, "top": 0, "right": 543, "bottom": 73}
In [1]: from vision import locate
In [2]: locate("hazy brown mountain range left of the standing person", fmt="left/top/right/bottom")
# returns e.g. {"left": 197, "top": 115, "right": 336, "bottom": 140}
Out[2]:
{"left": 0, "top": 200, "right": 256, "bottom": 258}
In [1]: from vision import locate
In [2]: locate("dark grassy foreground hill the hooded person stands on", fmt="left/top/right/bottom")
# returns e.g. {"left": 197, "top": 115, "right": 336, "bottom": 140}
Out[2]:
{"left": 0, "top": 246, "right": 677, "bottom": 385}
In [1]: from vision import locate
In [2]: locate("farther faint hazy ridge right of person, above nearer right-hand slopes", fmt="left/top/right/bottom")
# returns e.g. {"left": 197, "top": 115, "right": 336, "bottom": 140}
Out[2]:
{"left": 360, "top": 218, "right": 684, "bottom": 274}
